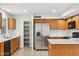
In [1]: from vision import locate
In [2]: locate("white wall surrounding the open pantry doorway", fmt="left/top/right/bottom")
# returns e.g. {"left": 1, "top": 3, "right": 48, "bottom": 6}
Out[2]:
{"left": 15, "top": 16, "right": 32, "bottom": 48}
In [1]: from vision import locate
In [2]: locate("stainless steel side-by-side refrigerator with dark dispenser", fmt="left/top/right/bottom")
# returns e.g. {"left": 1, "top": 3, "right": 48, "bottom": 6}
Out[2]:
{"left": 34, "top": 23, "right": 49, "bottom": 50}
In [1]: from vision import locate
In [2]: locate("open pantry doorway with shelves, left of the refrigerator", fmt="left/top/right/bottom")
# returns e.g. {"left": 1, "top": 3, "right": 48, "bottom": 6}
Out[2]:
{"left": 24, "top": 21, "right": 30, "bottom": 47}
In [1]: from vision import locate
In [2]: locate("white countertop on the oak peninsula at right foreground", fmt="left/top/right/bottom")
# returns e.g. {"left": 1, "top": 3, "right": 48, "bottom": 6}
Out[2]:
{"left": 48, "top": 38, "right": 79, "bottom": 44}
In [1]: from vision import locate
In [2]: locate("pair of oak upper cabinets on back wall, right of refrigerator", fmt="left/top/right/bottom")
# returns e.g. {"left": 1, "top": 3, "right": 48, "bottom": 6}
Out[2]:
{"left": 48, "top": 19, "right": 66, "bottom": 30}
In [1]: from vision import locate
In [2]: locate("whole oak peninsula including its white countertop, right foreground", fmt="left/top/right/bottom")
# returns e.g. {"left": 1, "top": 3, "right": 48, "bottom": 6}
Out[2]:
{"left": 48, "top": 38, "right": 79, "bottom": 56}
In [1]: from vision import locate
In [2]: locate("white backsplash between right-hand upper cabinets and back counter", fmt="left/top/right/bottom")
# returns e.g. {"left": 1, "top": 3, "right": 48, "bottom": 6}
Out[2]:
{"left": 49, "top": 29, "right": 79, "bottom": 36}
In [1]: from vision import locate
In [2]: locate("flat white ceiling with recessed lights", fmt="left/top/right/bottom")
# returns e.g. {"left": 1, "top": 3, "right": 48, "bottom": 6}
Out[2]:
{"left": 0, "top": 3, "right": 79, "bottom": 17}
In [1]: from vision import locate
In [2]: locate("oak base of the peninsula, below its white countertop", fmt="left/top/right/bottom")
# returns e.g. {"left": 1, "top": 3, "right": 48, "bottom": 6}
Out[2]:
{"left": 48, "top": 44, "right": 79, "bottom": 56}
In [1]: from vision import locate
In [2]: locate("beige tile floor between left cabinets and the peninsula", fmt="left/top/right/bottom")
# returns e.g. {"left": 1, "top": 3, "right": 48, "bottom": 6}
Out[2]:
{"left": 12, "top": 47, "right": 48, "bottom": 56}
